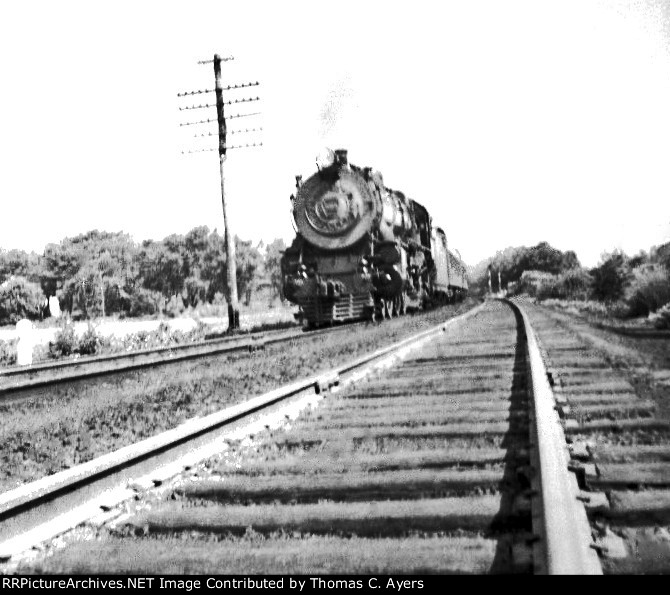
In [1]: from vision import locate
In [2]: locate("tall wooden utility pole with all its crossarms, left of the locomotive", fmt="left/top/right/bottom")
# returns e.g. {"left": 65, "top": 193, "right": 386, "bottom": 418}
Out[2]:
{"left": 177, "top": 54, "right": 263, "bottom": 331}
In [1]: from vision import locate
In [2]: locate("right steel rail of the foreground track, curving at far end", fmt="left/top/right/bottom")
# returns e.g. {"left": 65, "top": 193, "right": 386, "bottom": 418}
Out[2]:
{"left": 510, "top": 300, "right": 602, "bottom": 574}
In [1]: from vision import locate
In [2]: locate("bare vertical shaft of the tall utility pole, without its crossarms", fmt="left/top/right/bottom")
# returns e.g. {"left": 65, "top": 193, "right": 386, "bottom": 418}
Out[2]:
{"left": 214, "top": 54, "right": 240, "bottom": 330}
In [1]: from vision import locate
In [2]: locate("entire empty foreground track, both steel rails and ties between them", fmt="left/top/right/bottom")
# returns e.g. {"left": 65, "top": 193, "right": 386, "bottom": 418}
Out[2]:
{"left": 0, "top": 302, "right": 601, "bottom": 574}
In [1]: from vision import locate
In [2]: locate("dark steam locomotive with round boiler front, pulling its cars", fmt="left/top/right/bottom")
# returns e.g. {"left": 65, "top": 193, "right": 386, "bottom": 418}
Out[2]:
{"left": 281, "top": 149, "right": 468, "bottom": 328}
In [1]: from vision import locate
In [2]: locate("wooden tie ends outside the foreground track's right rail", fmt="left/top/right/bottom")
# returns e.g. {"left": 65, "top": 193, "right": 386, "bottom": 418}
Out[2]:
{"left": 524, "top": 304, "right": 670, "bottom": 574}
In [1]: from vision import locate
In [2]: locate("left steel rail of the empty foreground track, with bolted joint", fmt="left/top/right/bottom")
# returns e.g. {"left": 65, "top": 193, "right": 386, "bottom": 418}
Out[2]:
{"left": 0, "top": 304, "right": 484, "bottom": 561}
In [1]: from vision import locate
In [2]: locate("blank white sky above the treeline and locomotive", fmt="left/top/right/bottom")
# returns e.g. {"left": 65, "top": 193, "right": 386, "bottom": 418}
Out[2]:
{"left": 0, "top": 0, "right": 670, "bottom": 266}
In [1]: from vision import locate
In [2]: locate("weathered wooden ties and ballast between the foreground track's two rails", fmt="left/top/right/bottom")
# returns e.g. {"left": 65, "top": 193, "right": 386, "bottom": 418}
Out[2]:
{"left": 20, "top": 302, "right": 552, "bottom": 574}
